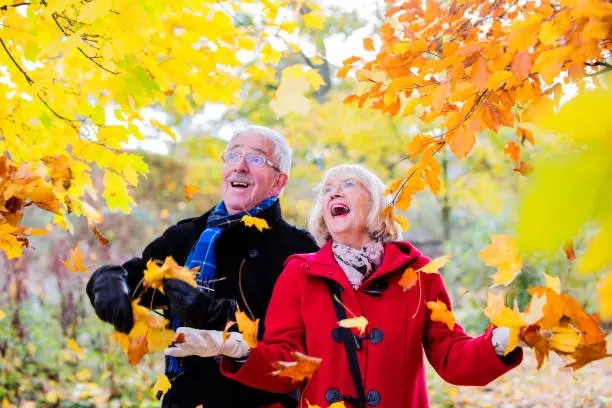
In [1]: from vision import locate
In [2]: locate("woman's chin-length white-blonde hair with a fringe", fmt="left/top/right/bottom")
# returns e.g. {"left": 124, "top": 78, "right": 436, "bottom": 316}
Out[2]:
{"left": 308, "top": 164, "right": 400, "bottom": 246}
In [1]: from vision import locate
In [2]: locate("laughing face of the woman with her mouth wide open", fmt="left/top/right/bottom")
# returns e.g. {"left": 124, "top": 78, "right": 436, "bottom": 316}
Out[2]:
{"left": 321, "top": 177, "right": 370, "bottom": 243}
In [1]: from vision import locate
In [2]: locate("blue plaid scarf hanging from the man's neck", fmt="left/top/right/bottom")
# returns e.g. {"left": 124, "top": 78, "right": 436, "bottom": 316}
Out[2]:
{"left": 166, "top": 196, "right": 278, "bottom": 374}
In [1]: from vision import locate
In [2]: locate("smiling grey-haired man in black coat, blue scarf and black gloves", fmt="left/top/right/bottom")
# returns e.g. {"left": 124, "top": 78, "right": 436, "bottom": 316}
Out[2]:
{"left": 87, "top": 126, "right": 318, "bottom": 408}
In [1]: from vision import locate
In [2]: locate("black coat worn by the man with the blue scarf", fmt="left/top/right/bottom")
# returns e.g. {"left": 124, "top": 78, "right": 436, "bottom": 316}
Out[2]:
{"left": 92, "top": 201, "right": 318, "bottom": 408}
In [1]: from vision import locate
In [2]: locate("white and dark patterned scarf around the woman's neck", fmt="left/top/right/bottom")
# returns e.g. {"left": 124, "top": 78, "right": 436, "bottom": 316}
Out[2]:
{"left": 332, "top": 240, "right": 385, "bottom": 290}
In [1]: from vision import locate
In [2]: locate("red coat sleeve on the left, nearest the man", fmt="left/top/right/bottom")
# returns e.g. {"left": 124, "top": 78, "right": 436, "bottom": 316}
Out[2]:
{"left": 221, "top": 259, "right": 305, "bottom": 393}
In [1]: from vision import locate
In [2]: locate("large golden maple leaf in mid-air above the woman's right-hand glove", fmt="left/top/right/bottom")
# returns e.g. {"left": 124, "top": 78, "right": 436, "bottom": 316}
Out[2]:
{"left": 478, "top": 235, "right": 523, "bottom": 286}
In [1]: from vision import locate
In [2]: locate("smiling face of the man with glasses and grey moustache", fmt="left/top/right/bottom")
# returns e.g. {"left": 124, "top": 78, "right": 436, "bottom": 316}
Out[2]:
{"left": 221, "top": 134, "right": 287, "bottom": 215}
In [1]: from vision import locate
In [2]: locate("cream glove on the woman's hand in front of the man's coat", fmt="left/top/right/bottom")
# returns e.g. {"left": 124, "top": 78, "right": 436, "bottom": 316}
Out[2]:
{"left": 164, "top": 327, "right": 250, "bottom": 358}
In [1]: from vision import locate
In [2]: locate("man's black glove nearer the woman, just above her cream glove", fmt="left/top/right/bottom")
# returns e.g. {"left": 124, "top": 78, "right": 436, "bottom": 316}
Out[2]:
{"left": 164, "top": 279, "right": 236, "bottom": 330}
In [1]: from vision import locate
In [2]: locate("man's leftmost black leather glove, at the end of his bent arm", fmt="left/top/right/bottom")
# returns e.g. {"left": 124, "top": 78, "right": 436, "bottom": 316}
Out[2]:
{"left": 87, "top": 266, "right": 134, "bottom": 333}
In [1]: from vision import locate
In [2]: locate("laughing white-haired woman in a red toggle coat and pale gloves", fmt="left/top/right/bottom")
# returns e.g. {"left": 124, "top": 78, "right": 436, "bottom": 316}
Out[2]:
{"left": 166, "top": 165, "right": 522, "bottom": 408}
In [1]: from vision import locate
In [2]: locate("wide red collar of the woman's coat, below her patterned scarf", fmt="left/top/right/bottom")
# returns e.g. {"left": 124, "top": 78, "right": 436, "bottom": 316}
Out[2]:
{"left": 306, "top": 240, "right": 422, "bottom": 286}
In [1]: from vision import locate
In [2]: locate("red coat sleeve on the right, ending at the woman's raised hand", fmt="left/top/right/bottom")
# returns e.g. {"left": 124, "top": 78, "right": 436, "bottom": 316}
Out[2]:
{"left": 423, "top": 274, "right": 523, "bottom": 386}
